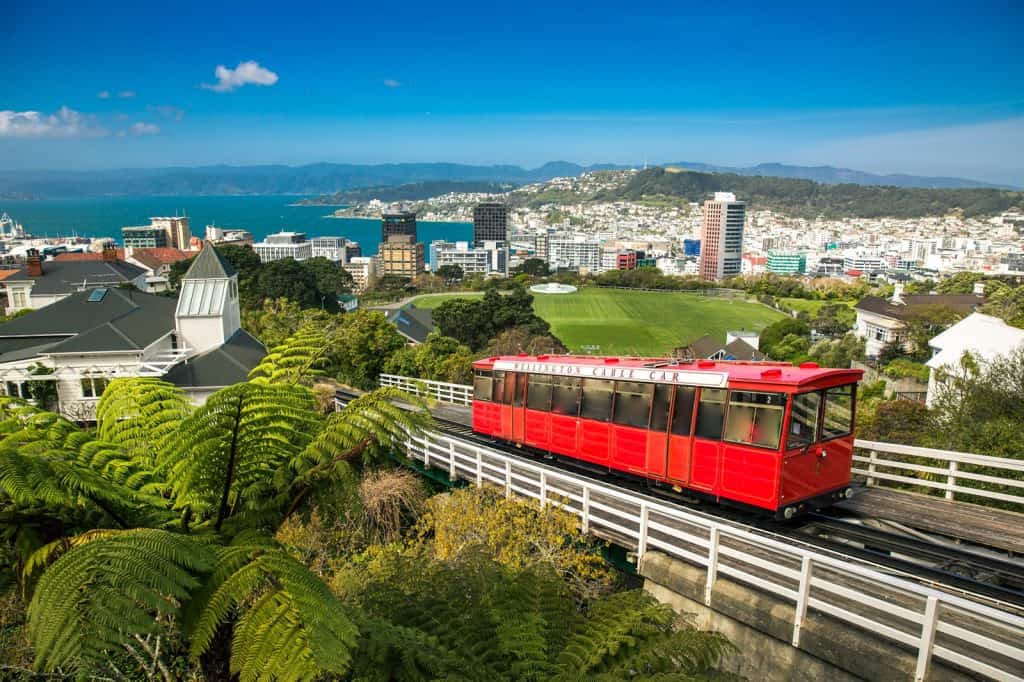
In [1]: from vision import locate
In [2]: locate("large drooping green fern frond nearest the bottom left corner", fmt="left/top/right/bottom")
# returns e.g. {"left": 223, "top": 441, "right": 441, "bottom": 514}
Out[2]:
{"left": 29, "top": 528, "right": 215, "bottom": 672}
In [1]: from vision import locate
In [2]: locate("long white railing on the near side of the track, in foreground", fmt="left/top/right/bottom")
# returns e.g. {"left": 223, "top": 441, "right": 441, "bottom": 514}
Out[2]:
{"left": 407, "top": 432, "right": 1024, "bottom": 680}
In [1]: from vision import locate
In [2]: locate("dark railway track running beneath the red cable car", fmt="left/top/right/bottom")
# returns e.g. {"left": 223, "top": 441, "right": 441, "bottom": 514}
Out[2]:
{"left": 339, "top": 391, "right": 1024, "bottom": 614}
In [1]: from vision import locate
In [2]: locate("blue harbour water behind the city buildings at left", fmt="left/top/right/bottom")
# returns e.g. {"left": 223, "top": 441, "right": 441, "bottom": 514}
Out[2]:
{"left": 0, "top": 196, "right": 473, "bottom": 255}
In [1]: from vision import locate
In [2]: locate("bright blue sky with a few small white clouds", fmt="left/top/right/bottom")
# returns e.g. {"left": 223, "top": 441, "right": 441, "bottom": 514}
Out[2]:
{"left": 0, "top": 0, "right": 1024, "bottom": 185}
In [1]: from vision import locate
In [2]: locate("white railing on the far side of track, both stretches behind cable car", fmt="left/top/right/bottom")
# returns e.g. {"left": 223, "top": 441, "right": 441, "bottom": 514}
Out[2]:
{"left": 381, "top": 374, "right": 1024, "bottom": 510}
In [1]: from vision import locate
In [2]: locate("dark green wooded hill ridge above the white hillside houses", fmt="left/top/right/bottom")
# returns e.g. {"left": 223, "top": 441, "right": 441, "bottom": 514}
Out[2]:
{"left": 597, "top": 168, "right": 1024, "bottom": 218}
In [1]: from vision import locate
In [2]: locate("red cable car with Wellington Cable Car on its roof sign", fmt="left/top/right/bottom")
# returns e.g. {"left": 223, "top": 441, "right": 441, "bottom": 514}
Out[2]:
{"left": 473, "top": 355, "right": 863, "bottom": 518}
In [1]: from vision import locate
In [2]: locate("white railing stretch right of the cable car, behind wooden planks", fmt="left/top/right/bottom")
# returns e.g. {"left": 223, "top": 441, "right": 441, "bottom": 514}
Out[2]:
{"left": 853, "top": 438, "right": 1024, "bottom": 510}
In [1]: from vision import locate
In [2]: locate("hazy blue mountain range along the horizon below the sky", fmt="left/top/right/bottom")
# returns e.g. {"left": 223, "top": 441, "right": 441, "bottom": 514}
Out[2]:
{"left": 0, "top": 161, "right": 1012, "bottom": 199}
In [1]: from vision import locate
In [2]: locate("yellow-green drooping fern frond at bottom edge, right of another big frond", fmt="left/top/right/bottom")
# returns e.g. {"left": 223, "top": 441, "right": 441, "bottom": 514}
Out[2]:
{"left": 186, "top": 545, "right": 357, "bottom": 682}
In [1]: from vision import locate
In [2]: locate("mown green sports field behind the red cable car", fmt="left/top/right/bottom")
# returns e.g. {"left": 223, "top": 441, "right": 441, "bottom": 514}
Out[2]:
{"left": 407, "top": 287, "right": 783, "bottom": 355}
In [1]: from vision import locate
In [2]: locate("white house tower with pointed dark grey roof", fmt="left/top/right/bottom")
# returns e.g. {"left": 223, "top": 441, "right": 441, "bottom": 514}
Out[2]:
{"left": 175, "top": 244, "right": 242, "bottom": 353}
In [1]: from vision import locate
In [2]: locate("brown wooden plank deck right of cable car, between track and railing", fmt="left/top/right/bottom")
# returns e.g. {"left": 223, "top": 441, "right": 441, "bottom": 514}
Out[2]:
{"left": 837, "top": 487, "right": 1024, "bottom": 554}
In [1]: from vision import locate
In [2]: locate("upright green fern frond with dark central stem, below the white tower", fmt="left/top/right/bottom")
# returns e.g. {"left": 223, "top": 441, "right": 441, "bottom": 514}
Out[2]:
{"left": 160, "top": 383, "right": 322, "bottom": 530}
